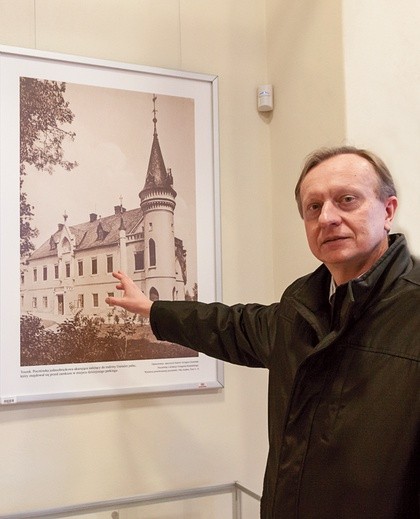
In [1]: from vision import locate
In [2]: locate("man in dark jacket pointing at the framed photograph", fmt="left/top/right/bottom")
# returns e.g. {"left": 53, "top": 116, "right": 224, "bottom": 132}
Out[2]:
{"left": 107, "top": 147, "right": 420, "bottom": 519}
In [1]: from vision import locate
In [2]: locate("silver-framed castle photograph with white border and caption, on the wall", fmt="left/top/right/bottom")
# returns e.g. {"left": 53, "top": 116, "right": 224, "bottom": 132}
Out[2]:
{"left": 0, "top": 46, "right": 223, "bottom": 404}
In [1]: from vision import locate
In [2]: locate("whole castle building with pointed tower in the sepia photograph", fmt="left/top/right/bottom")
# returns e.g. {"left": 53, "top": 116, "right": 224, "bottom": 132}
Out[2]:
{"left": 20, "top": 96, "right": 187, "bottom": 322}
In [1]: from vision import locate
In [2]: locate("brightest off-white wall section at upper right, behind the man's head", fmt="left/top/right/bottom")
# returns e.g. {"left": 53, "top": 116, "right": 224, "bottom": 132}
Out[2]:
{"left": 343, "top": 0, "right": 420, "bottom": 255}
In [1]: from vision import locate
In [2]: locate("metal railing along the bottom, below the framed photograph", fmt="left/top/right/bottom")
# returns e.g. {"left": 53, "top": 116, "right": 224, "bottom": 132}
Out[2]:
{"left": 0, "top": 481, "right": 261, "bottom": 519}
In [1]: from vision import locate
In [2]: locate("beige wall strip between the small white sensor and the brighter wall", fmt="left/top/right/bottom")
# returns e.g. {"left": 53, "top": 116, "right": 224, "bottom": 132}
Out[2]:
{"left": 267, "top": 0, "right": 345, "bottom": 295}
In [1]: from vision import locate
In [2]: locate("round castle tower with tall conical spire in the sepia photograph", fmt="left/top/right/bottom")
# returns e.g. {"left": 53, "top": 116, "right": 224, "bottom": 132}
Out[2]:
{"left": 139, "top": 96, "right": 176, "bottom": 300}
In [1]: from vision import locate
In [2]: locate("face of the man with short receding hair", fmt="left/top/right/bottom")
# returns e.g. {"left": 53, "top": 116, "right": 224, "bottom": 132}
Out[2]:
{"left": 300, "top": 154, "right": 397, "bottom": 284}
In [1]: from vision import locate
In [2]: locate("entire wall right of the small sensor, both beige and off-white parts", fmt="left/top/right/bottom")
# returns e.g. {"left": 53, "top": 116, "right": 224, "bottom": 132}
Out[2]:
{"left": 267, "top": 0, "right": 420, "bottom": 295}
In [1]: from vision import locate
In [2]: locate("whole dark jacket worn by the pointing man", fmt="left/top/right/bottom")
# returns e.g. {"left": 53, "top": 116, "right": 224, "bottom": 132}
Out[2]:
{"left": 151, "top": 235, "right": 420, "bottom": 519}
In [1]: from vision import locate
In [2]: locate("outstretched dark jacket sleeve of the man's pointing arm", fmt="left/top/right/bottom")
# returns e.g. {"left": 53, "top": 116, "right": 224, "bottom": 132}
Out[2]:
{"left": 150, "top": 301, "right": 276, "bottom": 367}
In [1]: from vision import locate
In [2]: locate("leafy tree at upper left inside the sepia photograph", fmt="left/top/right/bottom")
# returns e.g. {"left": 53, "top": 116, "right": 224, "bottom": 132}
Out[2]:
{"left": 20, "top": 77, "right": 77, "bottom": 256}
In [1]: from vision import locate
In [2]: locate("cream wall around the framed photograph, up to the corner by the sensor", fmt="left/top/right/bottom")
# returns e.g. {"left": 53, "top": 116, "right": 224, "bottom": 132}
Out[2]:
{"left": 0, "top": 0, "right": 274, "bottom": 517}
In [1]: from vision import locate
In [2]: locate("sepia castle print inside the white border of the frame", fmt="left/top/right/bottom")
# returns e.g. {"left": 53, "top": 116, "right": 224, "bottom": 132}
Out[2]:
{"left": 20, "top": 77, "right": 198, "bottom": 366}
